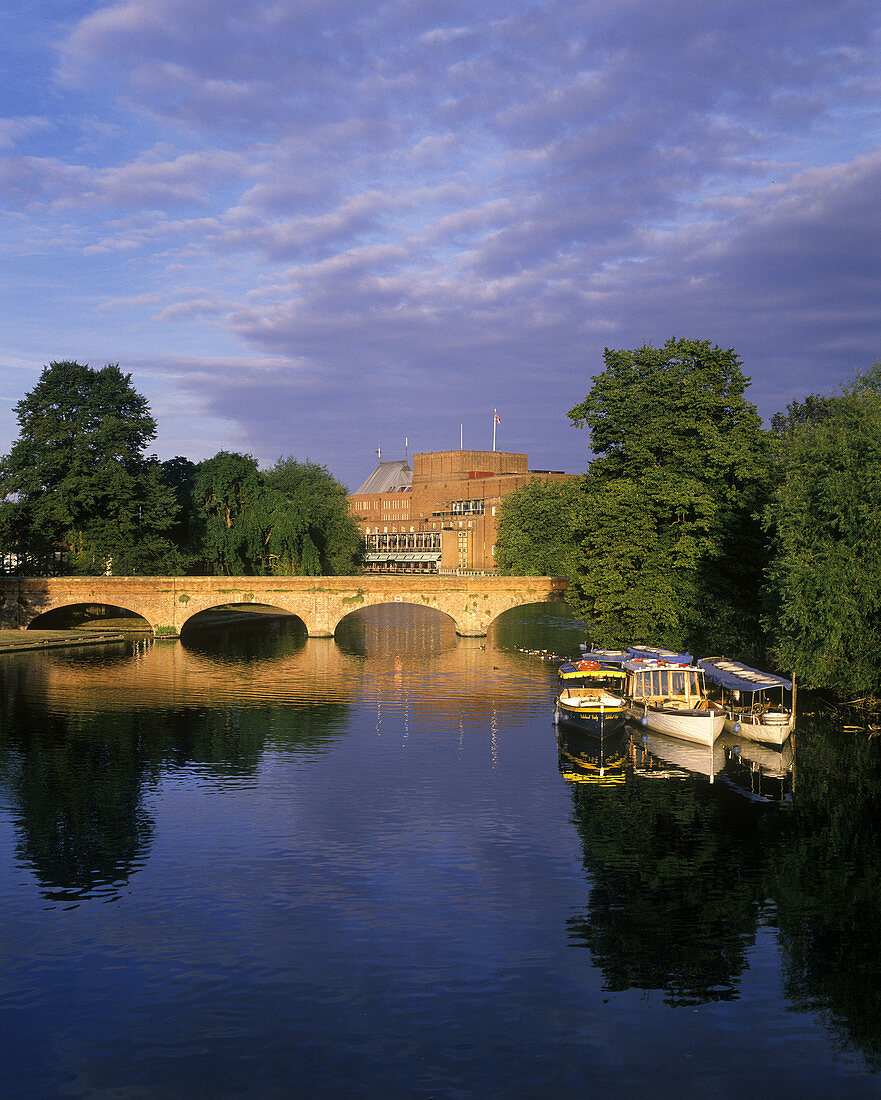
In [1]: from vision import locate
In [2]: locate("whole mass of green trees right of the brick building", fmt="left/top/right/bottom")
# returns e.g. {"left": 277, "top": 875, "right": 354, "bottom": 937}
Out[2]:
{"left": 496, "top": 339, "right": 881, "bottom": 695}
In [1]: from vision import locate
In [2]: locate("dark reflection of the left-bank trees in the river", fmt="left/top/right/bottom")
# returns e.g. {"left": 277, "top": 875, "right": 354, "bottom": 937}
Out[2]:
{"left": 0, "top": 636, "right": 349, "bottom": 901}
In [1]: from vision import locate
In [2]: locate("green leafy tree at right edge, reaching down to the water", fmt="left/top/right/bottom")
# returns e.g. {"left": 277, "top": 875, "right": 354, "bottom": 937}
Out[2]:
{"left": 767, "top": 364, "right": 881, "bottom": 693}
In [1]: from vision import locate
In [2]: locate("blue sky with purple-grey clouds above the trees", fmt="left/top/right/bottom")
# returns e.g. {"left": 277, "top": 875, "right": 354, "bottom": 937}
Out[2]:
{"left": 0, "top": 0, "right": 881, "bottom": 490}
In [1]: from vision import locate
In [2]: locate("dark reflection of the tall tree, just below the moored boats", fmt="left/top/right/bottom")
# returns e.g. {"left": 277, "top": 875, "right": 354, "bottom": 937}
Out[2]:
{"left": 569, "top": 777, "right": 767, "bottom": 1004}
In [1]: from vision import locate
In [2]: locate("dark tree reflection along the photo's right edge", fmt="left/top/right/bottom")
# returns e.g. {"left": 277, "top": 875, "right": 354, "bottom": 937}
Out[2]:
{"left": 777, "top": 719, "right": 881, "bottom": 1069}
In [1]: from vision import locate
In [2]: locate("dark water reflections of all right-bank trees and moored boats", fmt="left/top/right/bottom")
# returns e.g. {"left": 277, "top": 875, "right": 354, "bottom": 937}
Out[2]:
{"left": 560, "top": 704, "right": 881, "bottom": 1068}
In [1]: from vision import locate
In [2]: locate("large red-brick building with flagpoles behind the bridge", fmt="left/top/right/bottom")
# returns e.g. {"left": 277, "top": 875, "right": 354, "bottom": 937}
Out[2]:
{"left": 349, "top": 450, "right": 570, "bottom": 573}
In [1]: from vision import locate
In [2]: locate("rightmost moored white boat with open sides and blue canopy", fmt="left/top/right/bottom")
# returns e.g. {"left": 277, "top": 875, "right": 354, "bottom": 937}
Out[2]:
{"left": 698, "top": 657, "right": 795, "bottom": 745}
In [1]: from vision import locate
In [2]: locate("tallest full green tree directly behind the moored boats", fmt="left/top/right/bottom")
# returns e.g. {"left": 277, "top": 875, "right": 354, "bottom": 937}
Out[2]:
{"left": 569, "top": 339, "right": 768, "bottom": 656}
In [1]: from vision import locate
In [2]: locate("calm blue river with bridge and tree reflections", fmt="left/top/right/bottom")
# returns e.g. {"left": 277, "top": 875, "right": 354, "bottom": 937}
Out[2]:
{"left": 0, "top": 608, "right": 881, "bottom": 1098}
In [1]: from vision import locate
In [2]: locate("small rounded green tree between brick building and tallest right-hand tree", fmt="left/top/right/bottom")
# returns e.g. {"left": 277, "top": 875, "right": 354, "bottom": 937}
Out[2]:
{"left": 496, "top": 477, "right": 584, "bottom": 576}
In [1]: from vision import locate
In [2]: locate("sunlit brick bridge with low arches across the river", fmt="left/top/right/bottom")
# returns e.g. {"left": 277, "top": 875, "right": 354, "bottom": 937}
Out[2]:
{"left": 0, "top": 574, "right": 568, "bottom": 638}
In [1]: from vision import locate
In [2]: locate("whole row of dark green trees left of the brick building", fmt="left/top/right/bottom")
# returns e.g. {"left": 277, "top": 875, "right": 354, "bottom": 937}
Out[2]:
{"left": 0, "top": 361, "right": 361, "bottom": 575}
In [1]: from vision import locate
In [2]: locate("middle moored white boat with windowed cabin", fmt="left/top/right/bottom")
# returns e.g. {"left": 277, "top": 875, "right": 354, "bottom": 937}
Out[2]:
{"left": 624, "top": 646, "right": 725, "bottom": 745}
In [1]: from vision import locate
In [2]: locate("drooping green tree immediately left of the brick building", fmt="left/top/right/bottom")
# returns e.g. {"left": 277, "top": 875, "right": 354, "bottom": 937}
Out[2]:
{"left": 264, "top": 458, "right": 362, "bottom": 576}
